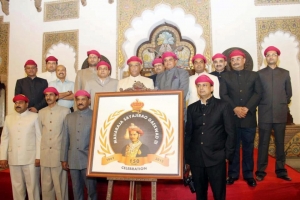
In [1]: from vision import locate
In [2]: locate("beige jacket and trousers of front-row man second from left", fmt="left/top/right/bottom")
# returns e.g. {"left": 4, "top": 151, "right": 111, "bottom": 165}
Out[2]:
{"left": 39, "top": 104, "right": 70, "bottom": 200}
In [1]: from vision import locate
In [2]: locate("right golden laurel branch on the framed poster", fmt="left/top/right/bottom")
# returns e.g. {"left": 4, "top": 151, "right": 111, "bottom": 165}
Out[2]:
{"left": 150, "top": 109, "right": 175, "bottom": 155}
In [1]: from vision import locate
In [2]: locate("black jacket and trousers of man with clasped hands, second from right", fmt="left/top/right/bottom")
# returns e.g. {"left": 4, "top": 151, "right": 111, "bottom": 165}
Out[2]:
{"left": 220, "top": 70, "right": 262, "bottom": 179}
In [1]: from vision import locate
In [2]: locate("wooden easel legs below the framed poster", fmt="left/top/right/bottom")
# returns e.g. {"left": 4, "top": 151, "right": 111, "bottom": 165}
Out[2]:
{"left": 106, "top": 177, "right": 157, "bottom": 200}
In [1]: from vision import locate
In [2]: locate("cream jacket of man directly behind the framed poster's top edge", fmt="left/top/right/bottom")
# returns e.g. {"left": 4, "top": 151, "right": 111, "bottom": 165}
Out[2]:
{"left": 117, "top": 75, "right": 154, "bottom": 91}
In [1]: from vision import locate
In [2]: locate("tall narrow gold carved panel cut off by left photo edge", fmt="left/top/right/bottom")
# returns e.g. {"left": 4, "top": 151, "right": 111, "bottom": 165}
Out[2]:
{"left": 0, "top": 17, "right": 9, "bottom": 81}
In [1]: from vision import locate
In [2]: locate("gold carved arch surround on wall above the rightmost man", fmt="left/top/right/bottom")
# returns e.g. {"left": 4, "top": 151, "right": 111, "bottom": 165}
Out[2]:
{"left": 256, "top": 17, "right": 300, "bottom": 66}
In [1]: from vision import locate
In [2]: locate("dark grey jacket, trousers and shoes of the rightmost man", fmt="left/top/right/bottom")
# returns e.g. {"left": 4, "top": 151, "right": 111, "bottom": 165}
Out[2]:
{"left": 256, "top": 66, "right": 292, "bottom": 176}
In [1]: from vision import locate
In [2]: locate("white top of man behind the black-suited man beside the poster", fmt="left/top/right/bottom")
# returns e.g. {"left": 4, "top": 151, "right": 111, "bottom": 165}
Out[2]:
{"left": 187, "top": 72, "right": 220, "bottom": 105}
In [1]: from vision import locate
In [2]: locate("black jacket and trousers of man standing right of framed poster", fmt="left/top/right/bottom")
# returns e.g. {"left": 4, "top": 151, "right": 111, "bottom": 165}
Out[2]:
{"left": 184, "top": 97, "right": 236, "bottom": 199}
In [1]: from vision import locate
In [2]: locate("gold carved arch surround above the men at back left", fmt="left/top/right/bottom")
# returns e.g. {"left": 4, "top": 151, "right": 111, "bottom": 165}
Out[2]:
{"left": 42, "top": 30, "right": 79, "bottom": 72}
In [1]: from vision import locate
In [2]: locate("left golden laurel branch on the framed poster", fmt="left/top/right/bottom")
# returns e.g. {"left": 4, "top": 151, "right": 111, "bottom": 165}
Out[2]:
{"left": 97, "top": 110, "right": 124, "bottom": 154}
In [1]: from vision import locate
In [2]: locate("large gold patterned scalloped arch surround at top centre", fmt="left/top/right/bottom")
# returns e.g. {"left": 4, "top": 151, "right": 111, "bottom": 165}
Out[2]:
{"left": 117, "top": 0, "right": 212, "bottom": 72}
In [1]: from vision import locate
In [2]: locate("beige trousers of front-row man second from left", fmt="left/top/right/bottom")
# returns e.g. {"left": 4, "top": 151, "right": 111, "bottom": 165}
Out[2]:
{"left": 41, "top": 166, "right": 69, "bottom": 200}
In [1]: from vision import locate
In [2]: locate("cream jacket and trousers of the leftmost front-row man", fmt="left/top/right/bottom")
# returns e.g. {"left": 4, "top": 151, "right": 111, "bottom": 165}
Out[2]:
{"left": 0, "top": 110, "right": 41, "bottom": 200}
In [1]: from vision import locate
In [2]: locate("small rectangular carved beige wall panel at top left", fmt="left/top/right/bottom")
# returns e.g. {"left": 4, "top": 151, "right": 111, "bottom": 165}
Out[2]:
{"left": 44, "top": 0, "right": 79, "bottom": 22}
